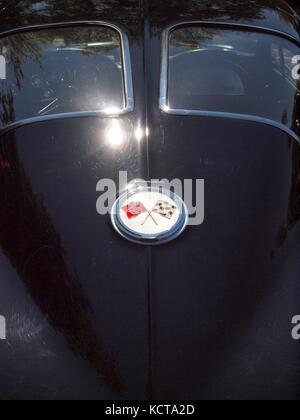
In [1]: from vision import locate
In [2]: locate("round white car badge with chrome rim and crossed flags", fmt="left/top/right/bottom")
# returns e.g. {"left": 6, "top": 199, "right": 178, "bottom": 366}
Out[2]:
{"left": 111, "top": 185, "right": 188, "bottom": 245}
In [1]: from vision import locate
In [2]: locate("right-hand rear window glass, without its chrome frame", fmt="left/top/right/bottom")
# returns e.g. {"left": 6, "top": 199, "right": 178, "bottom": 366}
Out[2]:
{"left": 167, "top": 26, "right": 300, "bottom": 135}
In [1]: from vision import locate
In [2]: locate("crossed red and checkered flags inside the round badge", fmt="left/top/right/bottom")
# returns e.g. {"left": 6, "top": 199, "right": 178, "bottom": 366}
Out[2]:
{"left": 122, "top": 200, "right": 178, "bottom": 226}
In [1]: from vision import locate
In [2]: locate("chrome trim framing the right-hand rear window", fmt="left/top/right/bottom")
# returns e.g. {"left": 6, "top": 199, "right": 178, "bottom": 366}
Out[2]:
{"left": 159, "top": 21, "right": 300, "bottom": 143}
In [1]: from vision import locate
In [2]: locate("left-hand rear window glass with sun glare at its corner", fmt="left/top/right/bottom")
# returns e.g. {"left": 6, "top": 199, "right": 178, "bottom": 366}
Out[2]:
{"left": 0, "top": 26, "right": 126, "bottom": 127}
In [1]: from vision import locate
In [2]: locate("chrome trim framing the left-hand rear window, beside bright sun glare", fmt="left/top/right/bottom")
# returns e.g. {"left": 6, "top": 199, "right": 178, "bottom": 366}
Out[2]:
{"left": 0, "top": 21, "right": 134, "bottom": 135}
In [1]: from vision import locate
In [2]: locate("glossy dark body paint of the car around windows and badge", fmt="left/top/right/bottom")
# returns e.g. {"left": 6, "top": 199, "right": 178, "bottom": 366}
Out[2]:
{"left": 0, "top": 0, "right": 300, "bottom": 399}
